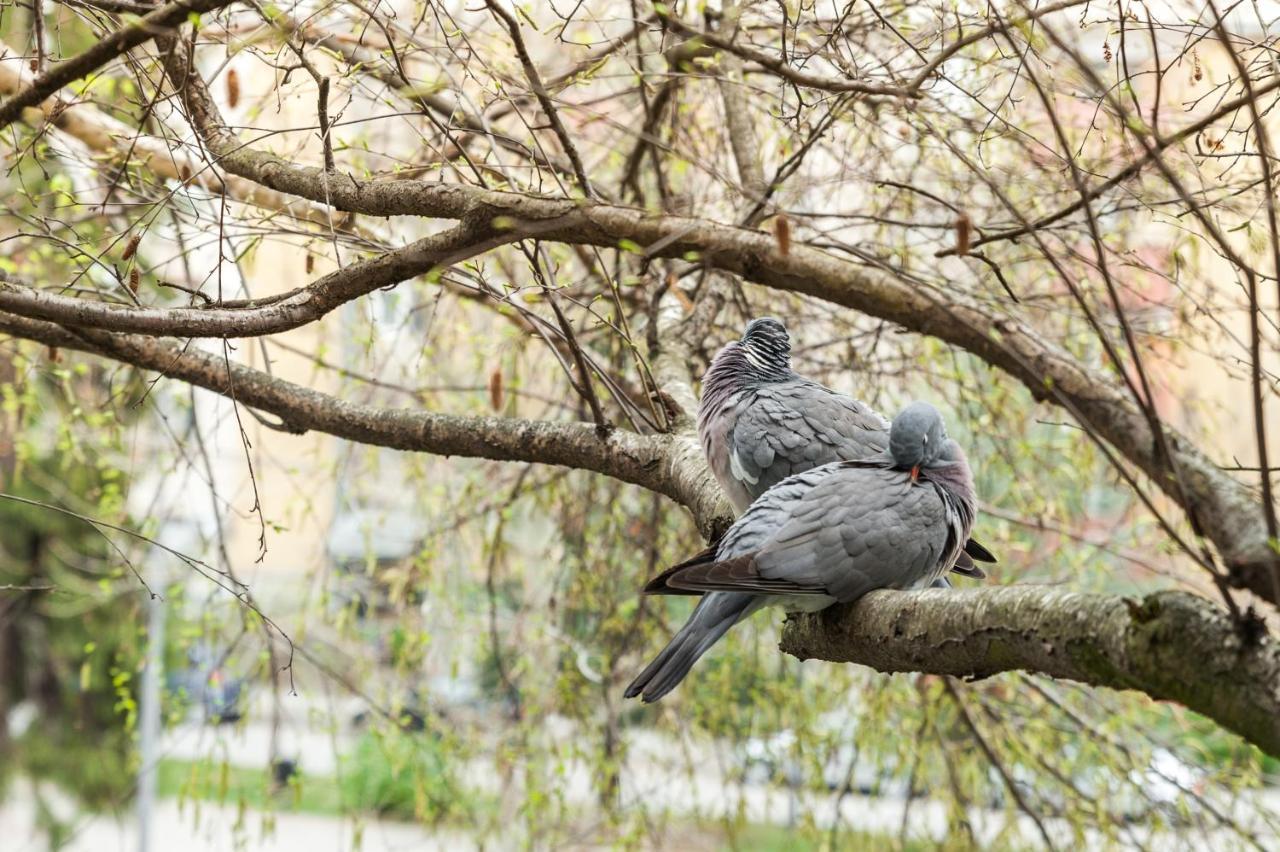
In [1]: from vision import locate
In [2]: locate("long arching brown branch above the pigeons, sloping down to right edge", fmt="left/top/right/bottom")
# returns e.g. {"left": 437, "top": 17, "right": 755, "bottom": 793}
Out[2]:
{"left": 169, "top": 51, "right": 1280, "bottom": 591}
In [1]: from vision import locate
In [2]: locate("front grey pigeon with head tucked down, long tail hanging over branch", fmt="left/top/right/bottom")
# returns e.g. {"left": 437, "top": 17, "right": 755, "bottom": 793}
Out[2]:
{"left": 625, "top": 402, "right": 978, "bottom": 704}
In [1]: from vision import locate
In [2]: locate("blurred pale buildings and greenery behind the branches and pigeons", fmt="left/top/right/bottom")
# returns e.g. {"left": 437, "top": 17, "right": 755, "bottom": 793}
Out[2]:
{"left": 0, "top": 0, "right": 1280, "bottom": 852}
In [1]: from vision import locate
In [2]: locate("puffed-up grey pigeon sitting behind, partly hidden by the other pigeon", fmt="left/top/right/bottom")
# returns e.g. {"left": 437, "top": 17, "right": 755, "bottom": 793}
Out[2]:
{"left": 698, "top": 316, "right": 996, "bottom": 585}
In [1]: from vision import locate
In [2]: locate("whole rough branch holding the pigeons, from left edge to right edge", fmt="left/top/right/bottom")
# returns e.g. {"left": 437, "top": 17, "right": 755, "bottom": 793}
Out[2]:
{"left": 0, "top": 315, "right": 1280, "bottom": 755}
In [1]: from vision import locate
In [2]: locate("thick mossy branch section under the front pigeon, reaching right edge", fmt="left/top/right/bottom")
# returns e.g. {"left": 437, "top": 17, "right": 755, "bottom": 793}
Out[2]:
{"left": 782, "top": 586, "right": 1280, "bottom": 756}
